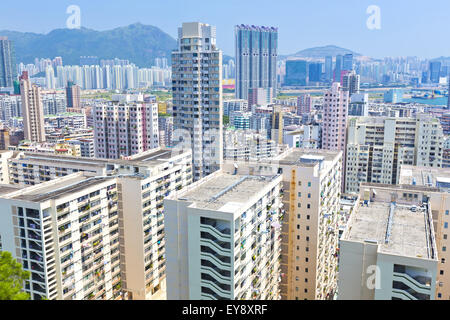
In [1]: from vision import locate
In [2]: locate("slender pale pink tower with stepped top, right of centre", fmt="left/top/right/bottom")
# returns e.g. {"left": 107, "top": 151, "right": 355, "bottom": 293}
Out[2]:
{"left": 322, "top": 82, "right": 350, "bottom": 152}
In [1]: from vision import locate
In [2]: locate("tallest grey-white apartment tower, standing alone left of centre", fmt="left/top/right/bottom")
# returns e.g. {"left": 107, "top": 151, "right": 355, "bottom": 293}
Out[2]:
{"left": 172, "top": 22, "right": 223, "bottom": 180}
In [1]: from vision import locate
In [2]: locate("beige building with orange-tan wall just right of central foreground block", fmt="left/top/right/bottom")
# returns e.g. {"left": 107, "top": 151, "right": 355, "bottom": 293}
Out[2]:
{"left": 224, "top": 149, "right": 342, "bottom": 300}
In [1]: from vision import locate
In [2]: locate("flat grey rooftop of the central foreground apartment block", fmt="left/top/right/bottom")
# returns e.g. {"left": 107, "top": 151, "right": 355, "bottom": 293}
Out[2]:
{"left": 177, "top": 172, "right": 278, "bottom": 213}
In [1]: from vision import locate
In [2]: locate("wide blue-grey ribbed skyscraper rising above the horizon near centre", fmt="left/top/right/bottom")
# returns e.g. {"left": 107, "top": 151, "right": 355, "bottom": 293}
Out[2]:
{"left": 235, "top": 24, "right": 278, "bottom": 100}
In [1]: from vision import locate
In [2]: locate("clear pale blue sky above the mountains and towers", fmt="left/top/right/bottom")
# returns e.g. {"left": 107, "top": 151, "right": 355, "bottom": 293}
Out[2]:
{"left": 0, "top": 0, "right": 450, "bottom": 58}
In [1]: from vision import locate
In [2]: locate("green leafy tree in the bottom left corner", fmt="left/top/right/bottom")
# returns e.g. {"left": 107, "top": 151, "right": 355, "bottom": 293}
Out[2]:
{"left": 0, "top": 251, "right": 30, "bottom": 300}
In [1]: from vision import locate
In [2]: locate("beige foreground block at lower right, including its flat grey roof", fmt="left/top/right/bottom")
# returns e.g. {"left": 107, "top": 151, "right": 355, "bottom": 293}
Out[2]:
{"left": 338, "top": 183, "right": 438, "bottom": 300}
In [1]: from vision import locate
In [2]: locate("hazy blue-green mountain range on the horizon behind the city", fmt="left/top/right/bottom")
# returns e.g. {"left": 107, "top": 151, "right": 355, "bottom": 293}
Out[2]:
{"left": 0, "top": 23, "right": 361, "bottom": 67}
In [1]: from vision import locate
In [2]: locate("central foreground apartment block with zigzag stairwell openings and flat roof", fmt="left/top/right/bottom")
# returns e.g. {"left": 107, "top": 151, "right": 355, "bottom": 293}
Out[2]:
{"left": 164, "top": 171, "right": 284, "bottom": 300}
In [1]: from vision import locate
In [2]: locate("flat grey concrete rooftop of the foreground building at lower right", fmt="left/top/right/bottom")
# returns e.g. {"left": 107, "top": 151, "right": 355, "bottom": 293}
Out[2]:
{"left": 343, "top": 202, "right": 434, "bottom": 258}
